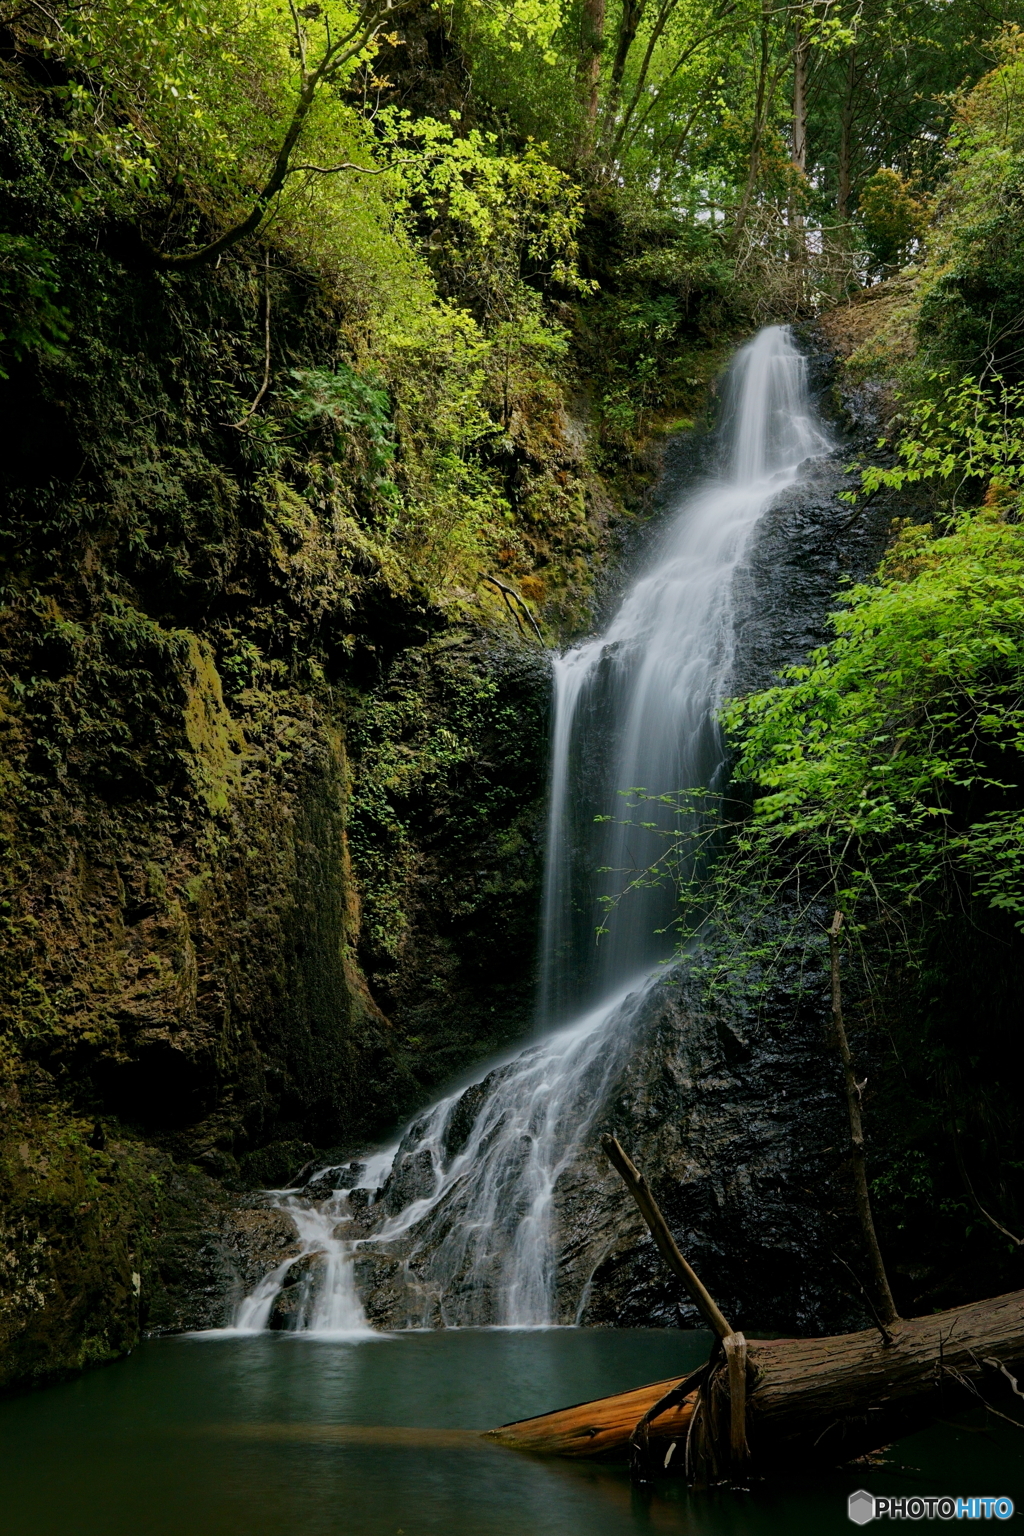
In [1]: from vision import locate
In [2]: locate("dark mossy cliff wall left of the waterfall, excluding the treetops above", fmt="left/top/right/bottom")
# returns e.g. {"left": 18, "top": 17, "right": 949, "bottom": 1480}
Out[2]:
{"left": 0, "top": 51, "right": 721, "bottom": 1387}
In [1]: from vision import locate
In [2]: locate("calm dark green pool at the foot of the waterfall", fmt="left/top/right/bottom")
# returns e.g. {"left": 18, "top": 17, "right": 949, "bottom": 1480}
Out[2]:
{"left": 0, "top": 1329, "right": 1024, "bottom": 1536}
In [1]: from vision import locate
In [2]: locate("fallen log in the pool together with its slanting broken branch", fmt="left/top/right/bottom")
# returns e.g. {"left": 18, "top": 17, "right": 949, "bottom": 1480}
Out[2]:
{"left": 487, "top": 1137, "right": 1024, "bottom": 1487}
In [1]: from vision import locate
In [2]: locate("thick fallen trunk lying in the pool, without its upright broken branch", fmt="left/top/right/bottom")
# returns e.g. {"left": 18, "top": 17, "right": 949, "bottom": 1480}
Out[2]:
{"left": 487, "top": 1290, "right": 1024, "bottom": 1473}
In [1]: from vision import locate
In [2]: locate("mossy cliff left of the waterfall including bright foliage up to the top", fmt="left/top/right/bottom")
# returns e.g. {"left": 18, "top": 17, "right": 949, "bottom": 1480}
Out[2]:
{"left": 0, "top": 0, "right": 752, "bottom": 1387}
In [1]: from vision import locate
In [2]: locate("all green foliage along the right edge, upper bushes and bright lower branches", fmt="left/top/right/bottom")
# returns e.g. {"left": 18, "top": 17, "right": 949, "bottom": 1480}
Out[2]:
{"left": 736, "top": 32, "right": 1024, "bottom": 926}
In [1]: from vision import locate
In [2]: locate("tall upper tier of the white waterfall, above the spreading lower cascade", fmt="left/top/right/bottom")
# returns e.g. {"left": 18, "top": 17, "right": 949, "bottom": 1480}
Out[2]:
{"left": 540, "top": 326, "right": 831, "bottom": 1025}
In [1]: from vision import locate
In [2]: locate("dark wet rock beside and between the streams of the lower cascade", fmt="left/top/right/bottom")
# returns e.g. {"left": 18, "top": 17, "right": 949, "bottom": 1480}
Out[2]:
{"left": 337, "top": 974, "right": 861, "bottom": 1332}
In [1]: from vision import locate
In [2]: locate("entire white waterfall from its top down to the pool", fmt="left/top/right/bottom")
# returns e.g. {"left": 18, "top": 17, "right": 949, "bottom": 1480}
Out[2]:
{"left": 236, "top": 326, "right": 831, "bottom": 1330}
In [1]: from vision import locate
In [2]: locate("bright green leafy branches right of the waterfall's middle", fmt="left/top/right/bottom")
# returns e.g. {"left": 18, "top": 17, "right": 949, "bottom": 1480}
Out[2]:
{"left": 726, "top": 516, "right": 1024, "bottom": 926}
